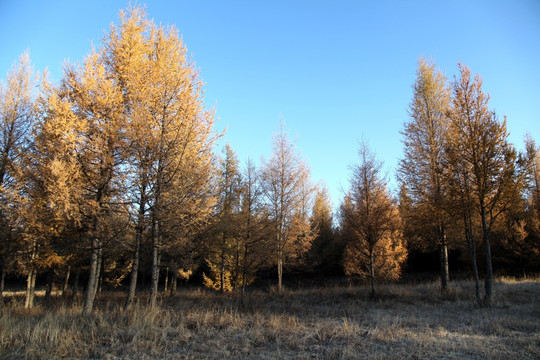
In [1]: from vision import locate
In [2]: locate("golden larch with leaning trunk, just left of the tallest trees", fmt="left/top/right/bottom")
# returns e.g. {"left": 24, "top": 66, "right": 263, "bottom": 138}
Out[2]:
{"left": 60, "top": 49, "right": 124, "bottom": 315}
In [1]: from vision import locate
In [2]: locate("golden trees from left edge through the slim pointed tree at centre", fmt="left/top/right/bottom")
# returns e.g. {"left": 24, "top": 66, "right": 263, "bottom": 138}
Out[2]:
{"left": 0, "top": 8, "right": 342, "bottom": 314}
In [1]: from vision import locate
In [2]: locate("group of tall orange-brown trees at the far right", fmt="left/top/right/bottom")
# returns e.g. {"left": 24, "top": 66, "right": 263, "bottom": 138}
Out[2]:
{"left": 398, "top": 59, "right": 539, "bottom": 305}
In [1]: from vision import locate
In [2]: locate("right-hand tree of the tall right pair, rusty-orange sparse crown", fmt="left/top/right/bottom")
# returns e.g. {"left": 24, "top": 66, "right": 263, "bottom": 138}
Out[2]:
{"left": 449, "top": 63, "right": 526, "bottom": 306}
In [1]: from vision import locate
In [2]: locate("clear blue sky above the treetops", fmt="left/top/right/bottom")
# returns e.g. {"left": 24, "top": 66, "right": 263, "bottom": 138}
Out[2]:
{"left": 0, "top": 0, "right": 540, "bottom": 205}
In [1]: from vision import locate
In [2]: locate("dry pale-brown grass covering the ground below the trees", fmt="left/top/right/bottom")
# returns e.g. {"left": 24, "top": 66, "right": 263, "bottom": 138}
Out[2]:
{"left": 0, "top": 279, "right": 540, "bottom": 359}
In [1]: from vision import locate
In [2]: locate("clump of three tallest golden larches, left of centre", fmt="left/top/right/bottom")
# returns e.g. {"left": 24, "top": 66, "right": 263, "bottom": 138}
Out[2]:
{"left": 62, "top": 7, "right": 216, "bottom": 314}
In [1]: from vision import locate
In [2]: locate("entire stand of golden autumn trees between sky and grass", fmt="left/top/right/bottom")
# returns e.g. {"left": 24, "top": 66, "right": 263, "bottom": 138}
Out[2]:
{"left": 0, "top": 8, "right": 540, "bottom": 315}
